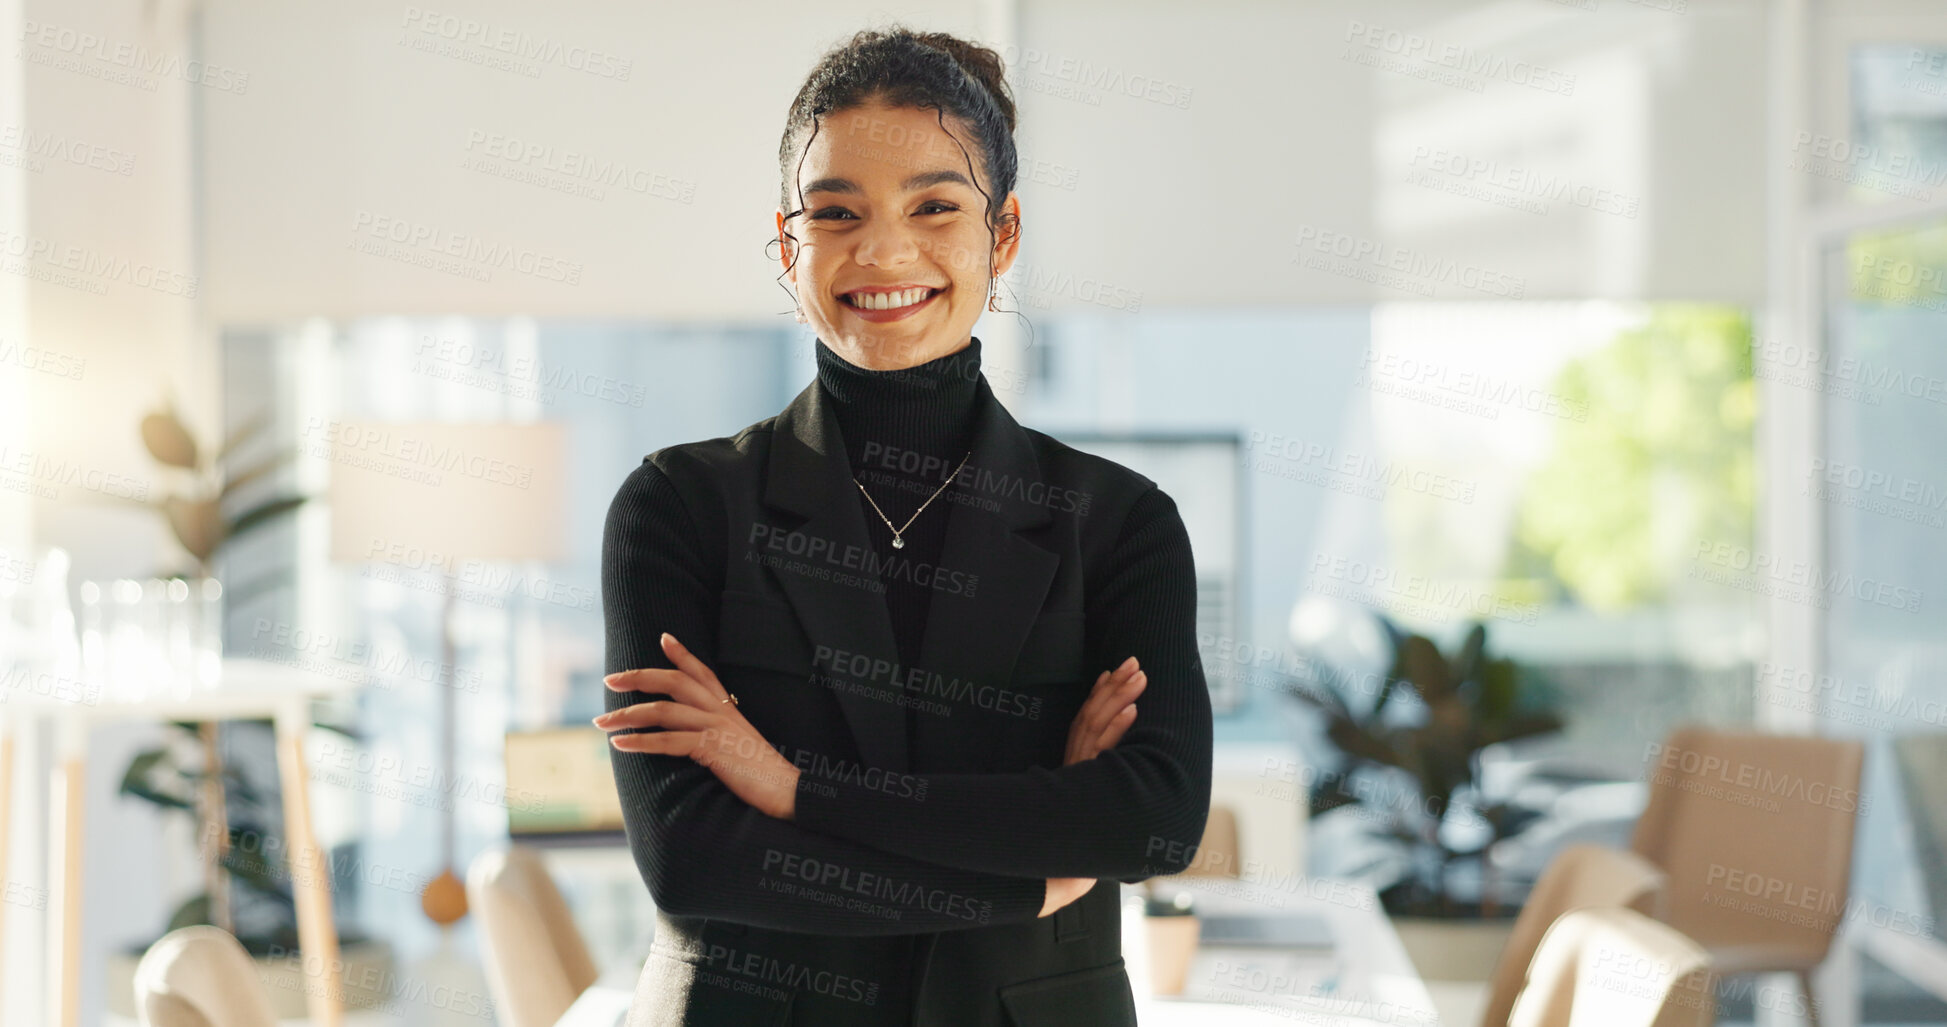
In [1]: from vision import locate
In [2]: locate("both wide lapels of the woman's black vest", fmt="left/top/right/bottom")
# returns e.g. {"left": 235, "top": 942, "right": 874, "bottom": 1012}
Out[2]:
{"left": 763, "top": 366, "right": 1061, "bottom": 774}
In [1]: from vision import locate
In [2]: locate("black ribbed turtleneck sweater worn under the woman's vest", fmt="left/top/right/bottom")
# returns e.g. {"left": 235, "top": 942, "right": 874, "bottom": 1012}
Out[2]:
{"left": 602, "top": 339, "right": 1209, "bottom": 935}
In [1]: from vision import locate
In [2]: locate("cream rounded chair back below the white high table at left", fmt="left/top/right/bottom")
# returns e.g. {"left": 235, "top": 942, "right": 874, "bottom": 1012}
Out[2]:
{"left": 134, "top": 924, "right": 276, "bottom": 1027}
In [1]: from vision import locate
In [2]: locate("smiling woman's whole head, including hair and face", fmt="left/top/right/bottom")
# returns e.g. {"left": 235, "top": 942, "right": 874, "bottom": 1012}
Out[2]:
{"left": 777, "top": 33, "right": 1020, "bottom": 368}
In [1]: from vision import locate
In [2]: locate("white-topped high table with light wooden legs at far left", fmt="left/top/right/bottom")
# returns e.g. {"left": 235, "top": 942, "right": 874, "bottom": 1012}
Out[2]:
{"left": 0, "top": 659, "right": 358, "bottom": 1027}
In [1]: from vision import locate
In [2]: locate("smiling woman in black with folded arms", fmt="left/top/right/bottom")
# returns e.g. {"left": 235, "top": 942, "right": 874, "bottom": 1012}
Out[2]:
{"left": 596, "top": 29, "right": 1211, "bottom": 1027}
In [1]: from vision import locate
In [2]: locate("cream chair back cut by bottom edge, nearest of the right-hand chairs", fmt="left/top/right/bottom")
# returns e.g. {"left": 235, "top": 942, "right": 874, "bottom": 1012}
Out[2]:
{"left": 1507, "top": 906, "right": 1717, "bottom": 1027}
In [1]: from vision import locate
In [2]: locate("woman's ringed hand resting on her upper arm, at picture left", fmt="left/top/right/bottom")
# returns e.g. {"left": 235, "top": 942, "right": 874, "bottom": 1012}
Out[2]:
{"left": 594, "top": 631, "right": 802, "bottom": 820}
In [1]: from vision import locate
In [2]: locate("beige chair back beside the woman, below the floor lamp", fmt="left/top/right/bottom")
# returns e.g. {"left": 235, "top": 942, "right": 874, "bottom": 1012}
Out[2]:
{"left": 467, "top": 846, "right": 598, "bottom": 1027}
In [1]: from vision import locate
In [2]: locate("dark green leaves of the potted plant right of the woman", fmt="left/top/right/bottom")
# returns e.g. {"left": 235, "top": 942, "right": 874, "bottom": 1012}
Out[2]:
{"left": 1285, "top": 614, "right": 1561, "bottom": 972}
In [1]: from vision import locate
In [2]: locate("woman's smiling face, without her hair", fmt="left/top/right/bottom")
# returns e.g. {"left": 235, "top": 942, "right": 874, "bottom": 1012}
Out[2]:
{"left": 777, "top": 99, "right": 1020, "bottom": 370}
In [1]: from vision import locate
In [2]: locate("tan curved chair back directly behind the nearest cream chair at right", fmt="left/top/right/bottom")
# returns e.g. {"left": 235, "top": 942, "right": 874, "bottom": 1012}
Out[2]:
{"left": 1480, "top": 846, "right": 1663, "bottom": 1027}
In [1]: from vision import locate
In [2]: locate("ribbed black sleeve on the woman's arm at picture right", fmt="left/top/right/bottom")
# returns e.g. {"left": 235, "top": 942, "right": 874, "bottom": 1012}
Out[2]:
{"left": 794, "top": 485, "right": 1211, "bottom": 883}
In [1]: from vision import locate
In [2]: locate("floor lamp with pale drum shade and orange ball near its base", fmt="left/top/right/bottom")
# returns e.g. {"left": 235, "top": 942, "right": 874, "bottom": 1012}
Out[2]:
{"left": 329, "top": 421, "right": 567, "bottom": 928}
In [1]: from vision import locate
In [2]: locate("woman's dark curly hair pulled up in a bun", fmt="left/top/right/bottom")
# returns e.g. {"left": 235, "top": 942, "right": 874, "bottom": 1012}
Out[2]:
{"left": 777, "top": 25, "right": 1020, "bottom": 317}
